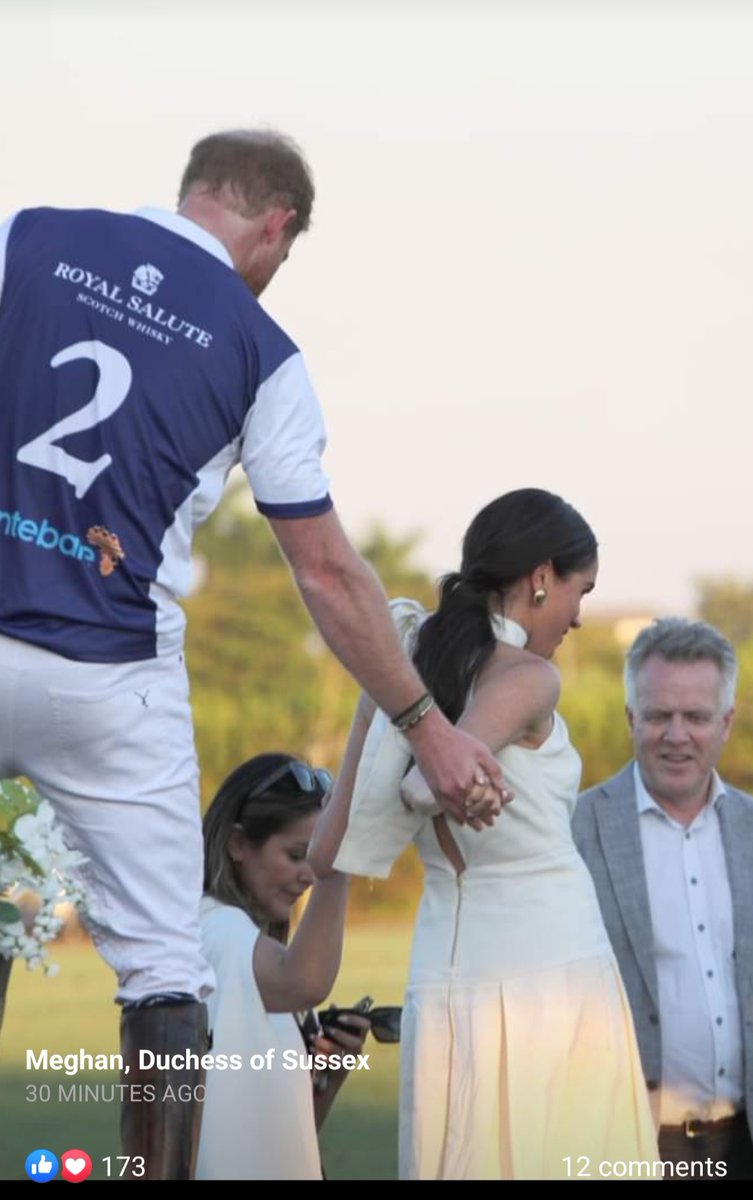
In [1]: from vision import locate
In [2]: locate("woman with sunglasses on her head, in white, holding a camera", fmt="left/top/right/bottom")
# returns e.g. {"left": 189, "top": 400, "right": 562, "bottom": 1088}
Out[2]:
{"left": 197, "top": 754, "right": 368, "bottom": 1180}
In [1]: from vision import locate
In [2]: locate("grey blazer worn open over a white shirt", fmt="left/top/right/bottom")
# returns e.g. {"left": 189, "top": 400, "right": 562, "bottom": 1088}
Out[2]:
{"left": 573, "top": 763, "right": 753, "bottom": 1132}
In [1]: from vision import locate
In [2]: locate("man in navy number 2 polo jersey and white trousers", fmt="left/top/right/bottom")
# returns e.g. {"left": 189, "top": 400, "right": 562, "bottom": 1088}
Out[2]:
{"left": 0, "top": 132, "right": 499, "bottom": 1178}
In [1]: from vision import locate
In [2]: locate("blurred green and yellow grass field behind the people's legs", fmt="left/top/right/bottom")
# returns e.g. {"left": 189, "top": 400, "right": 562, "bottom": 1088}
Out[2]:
{"left": 0, "top": 925, "right": 410, "bottom": 1180}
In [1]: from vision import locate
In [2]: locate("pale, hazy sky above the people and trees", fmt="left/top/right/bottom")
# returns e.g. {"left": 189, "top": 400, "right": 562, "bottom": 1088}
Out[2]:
{"left": 0, "top": 0, "right": 753, "bottom": 612}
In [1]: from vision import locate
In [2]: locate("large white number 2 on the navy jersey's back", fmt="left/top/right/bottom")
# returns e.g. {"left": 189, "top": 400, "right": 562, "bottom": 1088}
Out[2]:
{"left": 16, "top": 342, "right": 133, "bottom": 500}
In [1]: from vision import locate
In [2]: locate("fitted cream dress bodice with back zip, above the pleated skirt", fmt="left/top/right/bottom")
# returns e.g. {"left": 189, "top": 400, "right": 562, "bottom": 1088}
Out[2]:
{"left": 411, "top": 714, "right": 610, "bottom": 983}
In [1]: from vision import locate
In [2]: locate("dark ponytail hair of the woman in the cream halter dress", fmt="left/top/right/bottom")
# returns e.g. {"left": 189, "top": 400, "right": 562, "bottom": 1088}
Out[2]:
{"left": 414, "top": 487, "right": 597, "bottom": 722}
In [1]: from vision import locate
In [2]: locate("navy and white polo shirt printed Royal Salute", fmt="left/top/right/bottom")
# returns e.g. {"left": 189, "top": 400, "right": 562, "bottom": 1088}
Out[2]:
{"left": 0, "top": 209, "right": 332, "bottom": 662}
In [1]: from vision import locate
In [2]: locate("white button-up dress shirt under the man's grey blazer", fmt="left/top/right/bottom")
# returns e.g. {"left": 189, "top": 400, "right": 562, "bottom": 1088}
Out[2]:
{"left": 634, "top": 763, "right": 743, "bottom": 1124}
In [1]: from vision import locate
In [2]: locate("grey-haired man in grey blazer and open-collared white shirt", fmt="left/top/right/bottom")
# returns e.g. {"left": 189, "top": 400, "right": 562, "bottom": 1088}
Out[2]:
{"left": 573, "top": 617, "right": 753, "bottom": 1180}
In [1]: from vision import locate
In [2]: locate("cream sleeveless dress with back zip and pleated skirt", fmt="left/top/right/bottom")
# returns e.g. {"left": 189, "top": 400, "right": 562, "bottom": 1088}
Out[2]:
{"left": 333, "top": 609, "right": 658, "bottom": 1180}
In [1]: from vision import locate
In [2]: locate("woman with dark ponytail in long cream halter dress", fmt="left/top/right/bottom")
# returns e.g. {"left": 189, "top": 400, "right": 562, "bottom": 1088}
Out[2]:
{"left": 313, "top": 488, "right": 658, "bottom": 1180}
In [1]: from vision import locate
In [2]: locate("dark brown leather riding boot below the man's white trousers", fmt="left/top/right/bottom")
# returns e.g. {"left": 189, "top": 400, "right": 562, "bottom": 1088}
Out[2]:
{"left": 120, "top": 1001, "right": 209, "bottom": 1180}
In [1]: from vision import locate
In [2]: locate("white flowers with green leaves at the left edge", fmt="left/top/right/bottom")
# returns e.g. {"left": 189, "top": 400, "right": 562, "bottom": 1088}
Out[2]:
{"left": 0, "top": 779, "right": 85, "bottom": 974}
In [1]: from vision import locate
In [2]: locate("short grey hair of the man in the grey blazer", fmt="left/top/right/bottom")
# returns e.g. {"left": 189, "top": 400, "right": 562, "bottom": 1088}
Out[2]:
{"left": 625, "top": 617, "right": 737, "bottom": 713}
